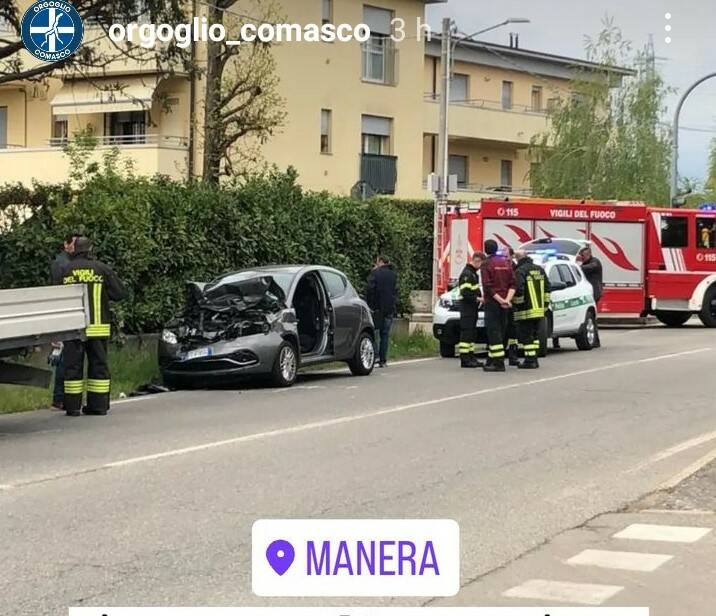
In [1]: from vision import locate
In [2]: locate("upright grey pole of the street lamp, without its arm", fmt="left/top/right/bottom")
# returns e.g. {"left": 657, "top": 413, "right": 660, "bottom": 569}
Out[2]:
{"left": 432, "top": 17, "right": 453, "bottom": 306}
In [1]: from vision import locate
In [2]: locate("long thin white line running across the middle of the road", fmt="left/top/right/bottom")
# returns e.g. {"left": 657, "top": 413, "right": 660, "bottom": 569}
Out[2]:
{"left": 1, "top": 347, "right": 712, "bottom": 489}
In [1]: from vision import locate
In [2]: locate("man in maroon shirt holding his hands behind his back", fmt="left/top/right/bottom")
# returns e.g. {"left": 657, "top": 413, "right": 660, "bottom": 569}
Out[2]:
{"left": 480, "top": 240, "right": 515, "bottom": 372}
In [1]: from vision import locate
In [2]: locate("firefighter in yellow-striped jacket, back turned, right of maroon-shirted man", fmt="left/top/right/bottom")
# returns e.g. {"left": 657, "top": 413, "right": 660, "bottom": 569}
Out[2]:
{"left": 513, "top": 250, "right": 550, "bottom": 369}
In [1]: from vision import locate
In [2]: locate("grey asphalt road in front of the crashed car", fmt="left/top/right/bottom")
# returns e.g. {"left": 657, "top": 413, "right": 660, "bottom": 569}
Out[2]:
{"left": 0, "top": 327, "right": 716, "bottom": 616}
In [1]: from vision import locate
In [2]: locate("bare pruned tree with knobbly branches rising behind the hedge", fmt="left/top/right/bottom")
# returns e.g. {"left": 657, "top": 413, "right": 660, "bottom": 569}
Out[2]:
{"left": 203, "top": 0, "right": 285, "bottom": 183}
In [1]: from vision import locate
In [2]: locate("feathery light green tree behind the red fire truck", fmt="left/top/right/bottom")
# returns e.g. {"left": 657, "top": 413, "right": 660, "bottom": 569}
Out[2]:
{"left": 530, "top": 20, "right": 671, "bottom": 204}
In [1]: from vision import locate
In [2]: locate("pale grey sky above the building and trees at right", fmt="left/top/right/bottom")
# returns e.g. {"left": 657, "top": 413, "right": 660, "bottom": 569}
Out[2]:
{"left": 427, "top": 0, "right": 716, "bottom": 180}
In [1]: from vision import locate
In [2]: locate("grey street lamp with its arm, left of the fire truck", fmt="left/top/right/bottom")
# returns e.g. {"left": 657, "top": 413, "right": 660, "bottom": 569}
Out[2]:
{"left": 432, "top": 17, "right": 531, "bottom": 306}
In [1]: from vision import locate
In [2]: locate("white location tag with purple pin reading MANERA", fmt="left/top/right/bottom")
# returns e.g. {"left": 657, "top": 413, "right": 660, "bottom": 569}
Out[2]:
{"left": 251, "top": 520, "right": 460, "bottom": 597}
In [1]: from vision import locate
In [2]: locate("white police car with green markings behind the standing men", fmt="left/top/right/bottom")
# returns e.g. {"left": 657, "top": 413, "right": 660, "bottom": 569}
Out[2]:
{"left": 433, "top": 240, "right": 597, "bottom": 357}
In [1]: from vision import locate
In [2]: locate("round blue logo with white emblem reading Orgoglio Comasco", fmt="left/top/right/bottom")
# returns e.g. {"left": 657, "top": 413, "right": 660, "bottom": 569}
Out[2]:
{"left": 20, "top": 0, "right": 84, "bottom": 62}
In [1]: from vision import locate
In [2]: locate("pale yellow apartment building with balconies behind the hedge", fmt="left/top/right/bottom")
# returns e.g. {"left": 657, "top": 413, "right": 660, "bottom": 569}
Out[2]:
{"left": 0, "top": 0, "right": 629, "bottom": 199}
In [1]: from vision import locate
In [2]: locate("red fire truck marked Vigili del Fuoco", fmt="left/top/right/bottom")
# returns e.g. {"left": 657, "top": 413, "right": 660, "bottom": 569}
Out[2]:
{"left": 438, "top": 198, "right": 716, "bottom": 327}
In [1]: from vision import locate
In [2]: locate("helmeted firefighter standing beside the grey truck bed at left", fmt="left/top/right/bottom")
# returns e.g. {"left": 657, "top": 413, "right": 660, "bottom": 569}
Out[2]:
{"left": 61, "top": 237, "right": 127, "bottom": 417}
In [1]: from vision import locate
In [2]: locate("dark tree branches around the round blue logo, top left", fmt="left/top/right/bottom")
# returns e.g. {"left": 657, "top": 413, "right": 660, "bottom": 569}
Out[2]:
{"left": 0, "top": 0, "right": 188, "bottom": 85}
